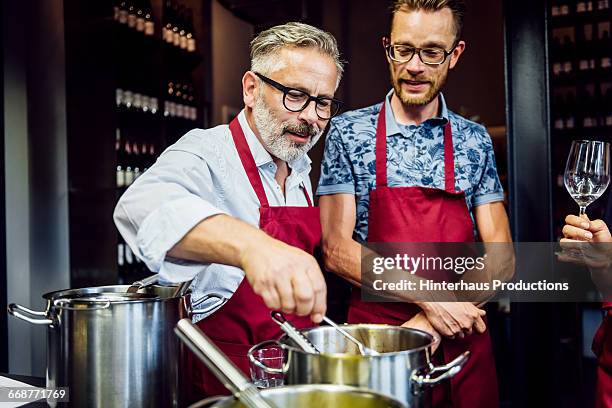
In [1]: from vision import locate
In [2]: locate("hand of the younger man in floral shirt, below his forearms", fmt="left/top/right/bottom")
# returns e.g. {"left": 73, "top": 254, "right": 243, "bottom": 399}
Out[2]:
{"left": 418, "top": 302, "right": 487, "bottom": 338}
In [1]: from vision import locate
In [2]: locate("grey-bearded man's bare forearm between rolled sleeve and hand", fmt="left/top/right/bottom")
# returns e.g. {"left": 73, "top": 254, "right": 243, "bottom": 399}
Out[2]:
{"left": 168, "top": 214, "right": 272, "bottom": 267}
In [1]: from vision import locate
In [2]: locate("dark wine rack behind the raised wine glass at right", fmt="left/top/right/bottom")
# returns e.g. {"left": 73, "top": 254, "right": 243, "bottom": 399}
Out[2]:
{"left": 548, "top": 0, "right": 612, "bottom": 238}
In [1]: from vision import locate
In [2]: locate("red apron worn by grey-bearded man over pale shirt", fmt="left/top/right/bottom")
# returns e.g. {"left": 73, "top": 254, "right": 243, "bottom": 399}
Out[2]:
{"left": 193, "top": 118, "right": 321, "bottom": 396}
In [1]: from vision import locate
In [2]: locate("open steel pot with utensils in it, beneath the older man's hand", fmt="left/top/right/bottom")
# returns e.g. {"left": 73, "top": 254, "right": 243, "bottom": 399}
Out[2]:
{"left": 249, "top": 324, "right": 469, "bottom": 408}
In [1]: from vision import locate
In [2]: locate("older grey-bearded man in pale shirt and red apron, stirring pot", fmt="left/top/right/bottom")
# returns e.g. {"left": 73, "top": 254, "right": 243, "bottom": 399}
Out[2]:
{"left": 114, "top": 23, "right": 343, "bottom": 395}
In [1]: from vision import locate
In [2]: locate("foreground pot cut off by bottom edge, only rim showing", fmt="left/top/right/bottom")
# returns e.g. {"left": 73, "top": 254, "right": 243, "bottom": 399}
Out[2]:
{"left": 189, "top": 384, "right": 404, "bottom": 408}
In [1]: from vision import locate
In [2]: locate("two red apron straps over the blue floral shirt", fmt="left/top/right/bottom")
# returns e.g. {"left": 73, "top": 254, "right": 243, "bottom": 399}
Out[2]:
{"left": 376, "top": 102, "right": 455, "bottom": 193}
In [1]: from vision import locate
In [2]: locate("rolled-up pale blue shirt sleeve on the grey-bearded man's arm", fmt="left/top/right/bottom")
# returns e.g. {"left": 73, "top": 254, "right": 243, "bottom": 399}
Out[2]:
{"left": 113, "top": 143, "right": 225, "bottom": 282}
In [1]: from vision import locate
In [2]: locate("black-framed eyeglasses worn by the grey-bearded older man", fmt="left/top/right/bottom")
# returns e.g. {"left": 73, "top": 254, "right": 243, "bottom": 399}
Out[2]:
{"left": 255, "top": 72, "right": 342, "bottom": 120}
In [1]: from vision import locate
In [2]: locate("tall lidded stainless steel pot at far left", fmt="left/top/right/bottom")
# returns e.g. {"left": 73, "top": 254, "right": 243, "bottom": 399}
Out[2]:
{"left": 8, "top": 285, "right": 218, "bottom": 407}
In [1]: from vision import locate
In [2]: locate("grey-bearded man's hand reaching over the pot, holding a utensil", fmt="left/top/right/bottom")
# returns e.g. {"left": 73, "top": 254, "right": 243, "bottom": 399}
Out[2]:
{"left": 240, "top": 239, "right": 327, "bottom": 323}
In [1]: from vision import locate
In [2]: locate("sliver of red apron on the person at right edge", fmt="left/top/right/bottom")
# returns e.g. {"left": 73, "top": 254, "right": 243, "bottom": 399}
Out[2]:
{"left": 593, "top": 302, "right": 612, "bottom": 408}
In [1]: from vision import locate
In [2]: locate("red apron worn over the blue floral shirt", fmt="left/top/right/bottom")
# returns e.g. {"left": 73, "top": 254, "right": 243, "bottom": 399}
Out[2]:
{"left": 348, "top": 103, "right": 499, "bottom": 408}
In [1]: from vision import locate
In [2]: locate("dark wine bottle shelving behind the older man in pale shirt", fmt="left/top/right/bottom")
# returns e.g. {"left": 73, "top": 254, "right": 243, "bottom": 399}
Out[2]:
{"left": 64, "top": 0, "right": 212, "bottom": 287}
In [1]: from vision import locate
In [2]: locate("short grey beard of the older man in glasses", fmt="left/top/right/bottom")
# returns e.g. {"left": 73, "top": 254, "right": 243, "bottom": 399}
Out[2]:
{"left": 253, "top": 96, "right": 323, "bottom": 162}
